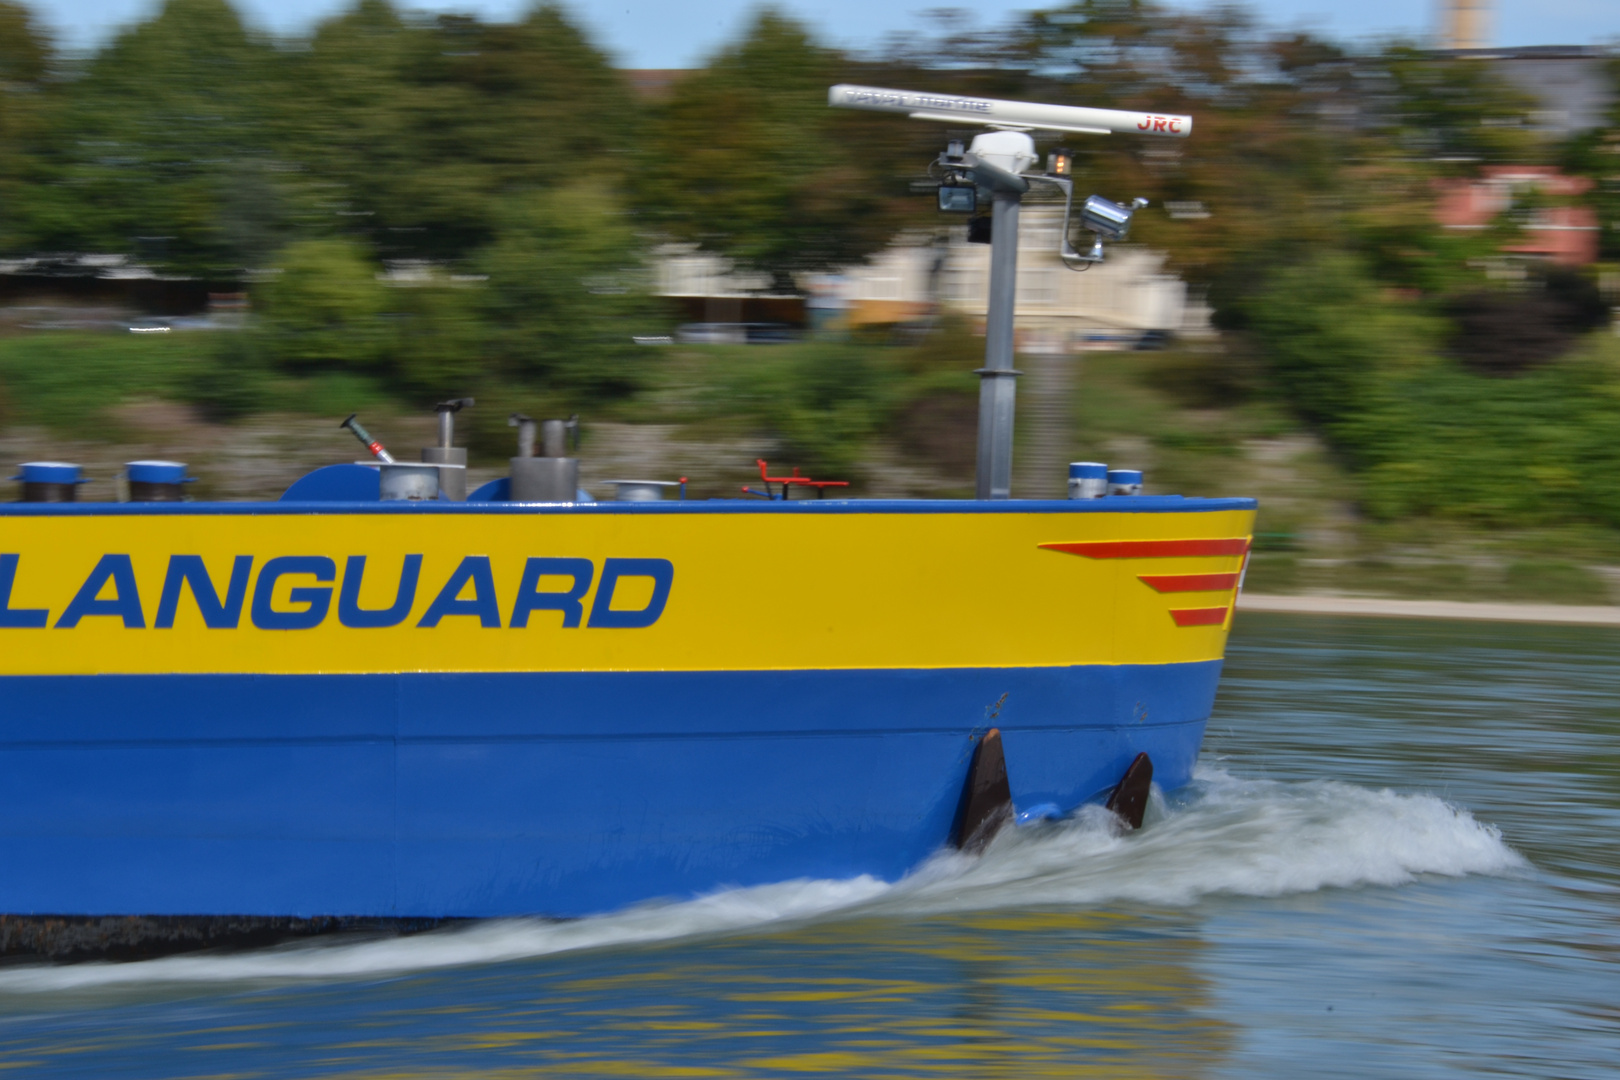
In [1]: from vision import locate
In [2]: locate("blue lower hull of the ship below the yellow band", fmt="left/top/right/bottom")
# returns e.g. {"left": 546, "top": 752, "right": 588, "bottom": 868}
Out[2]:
{"left": 0, "top": 661, "right": 1220, "bottom": 918}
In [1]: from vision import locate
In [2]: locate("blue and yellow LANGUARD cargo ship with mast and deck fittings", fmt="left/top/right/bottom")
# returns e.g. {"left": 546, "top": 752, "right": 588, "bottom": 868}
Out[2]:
{"left": 0, "top": 88, "right": 1256, "bottom": 955}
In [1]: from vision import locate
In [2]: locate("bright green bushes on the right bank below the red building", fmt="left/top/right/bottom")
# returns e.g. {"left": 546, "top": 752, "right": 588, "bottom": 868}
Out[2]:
{"left": 1252, "top": 254, "right": 1620, "bottom": 526}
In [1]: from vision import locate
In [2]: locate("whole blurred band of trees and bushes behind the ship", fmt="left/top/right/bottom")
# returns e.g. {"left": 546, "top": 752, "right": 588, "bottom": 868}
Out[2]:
{"left": 0, "top": 0, "right": 1620, "bottom": 550}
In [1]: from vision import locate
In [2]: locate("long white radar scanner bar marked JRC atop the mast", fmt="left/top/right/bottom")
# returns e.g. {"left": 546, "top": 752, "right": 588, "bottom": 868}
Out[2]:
{"left": 826, "top": 83, "right": 1192, "bottom": 139}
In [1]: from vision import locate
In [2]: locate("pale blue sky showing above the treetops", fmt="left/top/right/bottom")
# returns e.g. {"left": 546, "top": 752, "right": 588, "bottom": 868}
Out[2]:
{"left": 24, "top": 0, "right": 1620, "bottom": 68}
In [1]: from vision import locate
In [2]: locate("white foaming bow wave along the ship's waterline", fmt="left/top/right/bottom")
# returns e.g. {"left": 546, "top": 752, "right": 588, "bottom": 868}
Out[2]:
{"left": 0, "top": 771, "right": 1526, "bottom": 994}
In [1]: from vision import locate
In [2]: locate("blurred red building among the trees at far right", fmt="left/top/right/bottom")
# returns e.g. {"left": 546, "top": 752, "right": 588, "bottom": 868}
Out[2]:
{"left": 1435, "top": 165, "right": 1599, "bottom": 266}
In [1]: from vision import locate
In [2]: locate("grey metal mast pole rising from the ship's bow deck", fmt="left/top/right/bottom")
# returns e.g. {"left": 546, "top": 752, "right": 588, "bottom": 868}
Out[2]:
{"left": 977, "top": 191, "right": 1024, "bottom": 499}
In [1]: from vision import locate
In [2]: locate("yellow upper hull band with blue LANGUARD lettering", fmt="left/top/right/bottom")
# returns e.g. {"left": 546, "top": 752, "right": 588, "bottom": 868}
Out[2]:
{"left": 0, "top": 510, "right": 1254, "bottom": 675}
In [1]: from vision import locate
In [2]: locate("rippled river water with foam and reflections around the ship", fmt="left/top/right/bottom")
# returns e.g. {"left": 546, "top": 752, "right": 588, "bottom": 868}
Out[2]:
{"left": 0, "top": 614, "right": 1620, "bottom": 1080}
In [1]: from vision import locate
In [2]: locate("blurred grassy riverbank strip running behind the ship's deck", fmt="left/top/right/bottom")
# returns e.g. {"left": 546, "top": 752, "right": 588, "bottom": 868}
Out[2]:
{"left": 9, "top": 327, "right": 1620, "bottom": 608}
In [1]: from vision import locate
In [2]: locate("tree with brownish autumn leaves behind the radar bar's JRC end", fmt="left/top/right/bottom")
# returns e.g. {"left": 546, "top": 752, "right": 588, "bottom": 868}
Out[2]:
{"left": 959, "top": 0, "right": 1353, "bottom": 306}
